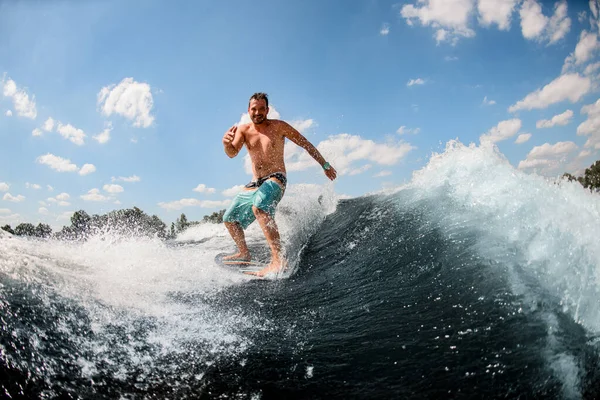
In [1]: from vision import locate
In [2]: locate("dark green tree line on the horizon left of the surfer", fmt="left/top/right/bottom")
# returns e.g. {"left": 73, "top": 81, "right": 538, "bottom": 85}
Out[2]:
{"left": 1, "top": 207, "right": 225, "bottom": 240}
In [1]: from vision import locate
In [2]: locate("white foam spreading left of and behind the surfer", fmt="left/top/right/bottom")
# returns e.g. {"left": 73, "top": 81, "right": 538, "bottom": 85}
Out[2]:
{"left": 0, "top": 181, "right": 335, "bottom": 379}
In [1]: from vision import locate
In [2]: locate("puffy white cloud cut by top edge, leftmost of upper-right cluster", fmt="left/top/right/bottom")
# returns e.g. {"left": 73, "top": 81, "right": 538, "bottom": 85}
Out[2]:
{"left": 400, "top": 0, "right": 475, "bottom": 44}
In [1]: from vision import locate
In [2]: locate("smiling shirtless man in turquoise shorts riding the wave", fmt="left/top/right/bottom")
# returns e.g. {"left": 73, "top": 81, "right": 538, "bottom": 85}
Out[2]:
{"left": 223, "top": 93, "right": 337, "bottom": 276}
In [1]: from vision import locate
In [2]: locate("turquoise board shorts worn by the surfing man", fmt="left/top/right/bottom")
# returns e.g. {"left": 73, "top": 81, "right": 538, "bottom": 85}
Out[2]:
{"left": 223, "top": 180, "right": 283, "bottom": 229}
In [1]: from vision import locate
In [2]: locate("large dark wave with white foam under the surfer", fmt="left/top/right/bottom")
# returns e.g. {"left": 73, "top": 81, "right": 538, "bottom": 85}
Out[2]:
{"left": 0, "top": 142, "right": 600, "bottom": 399}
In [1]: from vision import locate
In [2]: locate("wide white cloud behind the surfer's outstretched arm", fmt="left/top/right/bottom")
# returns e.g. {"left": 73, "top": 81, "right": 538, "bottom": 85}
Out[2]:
{"left": 285, "top": 133, "right": 414, "bottom": 174}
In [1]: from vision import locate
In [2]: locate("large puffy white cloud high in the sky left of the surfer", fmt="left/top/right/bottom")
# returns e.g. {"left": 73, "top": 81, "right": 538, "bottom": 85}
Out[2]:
{"left": 98, "top": 78, "right": 154, "bottom": 128}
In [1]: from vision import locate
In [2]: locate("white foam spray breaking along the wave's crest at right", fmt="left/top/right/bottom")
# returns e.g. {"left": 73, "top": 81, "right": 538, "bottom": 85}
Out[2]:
{"left": 409, "top": 141, "right": 600, "bottom": 398}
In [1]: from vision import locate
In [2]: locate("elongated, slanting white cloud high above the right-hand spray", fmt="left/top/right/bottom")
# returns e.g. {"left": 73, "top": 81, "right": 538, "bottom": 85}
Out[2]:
{"left": 508, "top": 74, "right": 592, "bottom": 112}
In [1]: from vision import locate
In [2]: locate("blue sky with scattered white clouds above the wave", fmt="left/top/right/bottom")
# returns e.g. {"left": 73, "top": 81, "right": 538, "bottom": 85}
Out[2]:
{"left": 0, "top": 0, "right": 600, "bottom": 227}
